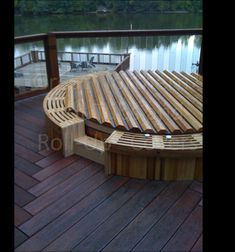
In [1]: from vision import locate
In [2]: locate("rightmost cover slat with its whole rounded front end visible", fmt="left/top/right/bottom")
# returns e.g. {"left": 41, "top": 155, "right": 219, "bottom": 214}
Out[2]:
{"left": 134, "top": 71, "right": 194, "bottom": 133}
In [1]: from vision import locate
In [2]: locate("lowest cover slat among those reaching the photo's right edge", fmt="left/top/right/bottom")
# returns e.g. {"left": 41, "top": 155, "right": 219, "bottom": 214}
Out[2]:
{"left": 141, "top": 71, "right": 202, "bottom": 132}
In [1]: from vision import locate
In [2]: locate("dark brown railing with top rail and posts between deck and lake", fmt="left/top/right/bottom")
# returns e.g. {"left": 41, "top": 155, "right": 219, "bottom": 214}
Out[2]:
{"left": 15, "top": 28, "right": 202, "bottom": 97}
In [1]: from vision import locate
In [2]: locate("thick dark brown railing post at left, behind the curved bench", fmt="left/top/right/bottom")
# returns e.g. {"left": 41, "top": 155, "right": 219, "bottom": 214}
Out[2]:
{"left": 44, "top": 33, "right": 60, "bottom": 89}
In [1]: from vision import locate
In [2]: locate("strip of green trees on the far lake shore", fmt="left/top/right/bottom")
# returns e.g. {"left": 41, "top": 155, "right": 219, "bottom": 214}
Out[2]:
{"left": 14, "top": 0, "right": 202, "bottom": 15}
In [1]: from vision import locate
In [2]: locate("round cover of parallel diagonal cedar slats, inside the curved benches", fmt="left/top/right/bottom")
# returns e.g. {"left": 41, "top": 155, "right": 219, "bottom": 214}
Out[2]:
{"left": 65, "top": 70, "right": 203, "bottom": 135}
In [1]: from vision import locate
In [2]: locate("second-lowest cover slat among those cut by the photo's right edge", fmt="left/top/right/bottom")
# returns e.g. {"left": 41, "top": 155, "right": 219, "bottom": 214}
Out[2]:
{"left": 152, "top": 70, "right": 202, "bottom": 123}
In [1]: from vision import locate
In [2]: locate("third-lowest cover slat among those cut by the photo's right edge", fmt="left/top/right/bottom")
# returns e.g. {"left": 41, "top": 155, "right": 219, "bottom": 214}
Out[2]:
{"left": 159, "top": 72, "right": 202, "bottom": 112}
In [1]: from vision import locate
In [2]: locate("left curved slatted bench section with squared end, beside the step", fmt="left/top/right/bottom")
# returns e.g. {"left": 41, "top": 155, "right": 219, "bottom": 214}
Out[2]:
{"left": 43, "top": 79, "right": 85, "bottom": 157}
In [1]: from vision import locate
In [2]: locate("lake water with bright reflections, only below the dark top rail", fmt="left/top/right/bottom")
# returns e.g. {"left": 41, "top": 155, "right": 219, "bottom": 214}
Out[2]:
{"left": 15, "top": 35, "right": 201, "bottom": 73}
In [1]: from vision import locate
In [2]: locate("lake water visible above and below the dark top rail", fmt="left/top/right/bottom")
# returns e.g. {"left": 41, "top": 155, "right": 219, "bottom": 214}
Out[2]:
{"left": 15, "top": 13, "right": 202, "bottom": 72}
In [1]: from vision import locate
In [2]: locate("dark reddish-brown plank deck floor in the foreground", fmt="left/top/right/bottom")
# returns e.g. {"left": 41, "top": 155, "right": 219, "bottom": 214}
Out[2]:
{"left": 15, "top": 95, "right": 202, "bottom": 251}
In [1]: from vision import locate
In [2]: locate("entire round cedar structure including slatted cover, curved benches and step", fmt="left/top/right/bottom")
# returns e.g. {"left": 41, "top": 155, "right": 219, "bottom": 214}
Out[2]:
{"left": 43, "top": 71, "right": 202, "bottom": 180}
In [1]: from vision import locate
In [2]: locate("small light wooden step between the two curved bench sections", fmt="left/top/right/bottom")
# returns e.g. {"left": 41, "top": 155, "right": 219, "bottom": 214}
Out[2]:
{"left": 74, "top": 136, "right": 104, "bottom": 164}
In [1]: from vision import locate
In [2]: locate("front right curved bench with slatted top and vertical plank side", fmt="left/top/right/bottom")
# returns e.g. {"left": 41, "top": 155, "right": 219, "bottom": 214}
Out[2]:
{"left": 105, "top": 131, "right": 202, "bottom": 180}
